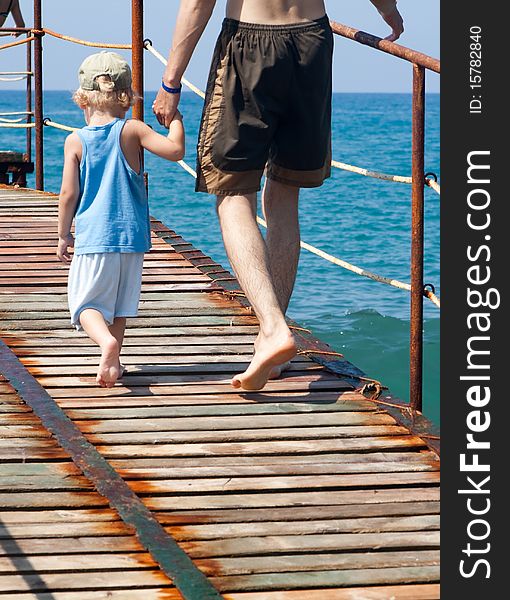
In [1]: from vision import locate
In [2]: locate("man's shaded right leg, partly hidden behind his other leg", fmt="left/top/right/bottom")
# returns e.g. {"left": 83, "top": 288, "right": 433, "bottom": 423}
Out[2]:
{"left": 262, "top": 179, "right": 301, "bottom": 379}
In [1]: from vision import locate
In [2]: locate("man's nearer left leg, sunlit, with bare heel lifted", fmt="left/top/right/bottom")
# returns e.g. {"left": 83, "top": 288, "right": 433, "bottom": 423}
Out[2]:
{"left": 217, "top": 194, "right": 296, "bottom": 390}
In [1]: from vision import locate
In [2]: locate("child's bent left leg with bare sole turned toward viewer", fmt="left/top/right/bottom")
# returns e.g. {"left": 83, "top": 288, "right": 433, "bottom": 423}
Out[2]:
{"left": 80, "top": 308, "right": 120, "bottom": 387}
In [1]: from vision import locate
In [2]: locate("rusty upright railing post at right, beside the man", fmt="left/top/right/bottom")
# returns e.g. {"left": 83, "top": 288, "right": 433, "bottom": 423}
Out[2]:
{"left": 409, "top": 64, "right": 425, "bottom": 412}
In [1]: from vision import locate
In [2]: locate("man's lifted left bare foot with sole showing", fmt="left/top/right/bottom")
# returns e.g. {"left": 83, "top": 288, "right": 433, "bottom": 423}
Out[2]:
{"left": 232, "top": 329, "right": 297, "bottom": 390}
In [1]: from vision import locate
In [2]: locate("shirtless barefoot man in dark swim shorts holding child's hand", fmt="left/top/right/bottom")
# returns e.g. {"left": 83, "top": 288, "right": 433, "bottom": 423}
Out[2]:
{"left": 153, "top": 0, "right": 403, "bottom": 390}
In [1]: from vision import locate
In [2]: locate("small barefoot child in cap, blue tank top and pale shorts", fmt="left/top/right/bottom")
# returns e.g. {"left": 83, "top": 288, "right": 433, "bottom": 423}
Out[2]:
{"left": 57, "top": 52, "right": 184, "bottom": 387}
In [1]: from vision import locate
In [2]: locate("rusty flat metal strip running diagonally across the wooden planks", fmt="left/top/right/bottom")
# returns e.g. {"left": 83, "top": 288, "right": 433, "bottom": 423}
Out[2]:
{"left": 0, "top": 340, "right": 223, "bottom": 600}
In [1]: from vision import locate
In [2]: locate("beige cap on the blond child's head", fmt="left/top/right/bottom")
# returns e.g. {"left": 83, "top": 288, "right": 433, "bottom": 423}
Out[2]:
{"left": 78, "top": 51, "right": 131, "bottom": 91}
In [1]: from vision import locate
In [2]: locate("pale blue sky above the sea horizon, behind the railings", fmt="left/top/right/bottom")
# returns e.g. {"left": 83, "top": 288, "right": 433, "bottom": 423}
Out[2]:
{"left": 0, "top": 0, "right": 440, "bottom": 92}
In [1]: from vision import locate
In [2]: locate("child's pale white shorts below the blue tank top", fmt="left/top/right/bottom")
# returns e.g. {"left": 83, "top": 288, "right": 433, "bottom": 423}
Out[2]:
{"left": 67, "top": 252, "right": 144, "bottom": 329}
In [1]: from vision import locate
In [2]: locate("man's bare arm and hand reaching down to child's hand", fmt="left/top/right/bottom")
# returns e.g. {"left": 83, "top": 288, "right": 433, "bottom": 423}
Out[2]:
{"left": 152, "top": 0, "right": 216, "bottom": 128}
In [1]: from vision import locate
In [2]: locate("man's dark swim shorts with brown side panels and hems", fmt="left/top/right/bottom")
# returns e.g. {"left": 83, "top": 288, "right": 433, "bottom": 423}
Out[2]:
{"left": 196, "top": 17, "right": 333, "bottom": 196}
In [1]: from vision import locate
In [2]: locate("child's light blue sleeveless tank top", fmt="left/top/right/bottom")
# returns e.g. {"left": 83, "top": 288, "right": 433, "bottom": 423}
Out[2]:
{"left": 75, "top": 119, "right": 151, "bottom": 254}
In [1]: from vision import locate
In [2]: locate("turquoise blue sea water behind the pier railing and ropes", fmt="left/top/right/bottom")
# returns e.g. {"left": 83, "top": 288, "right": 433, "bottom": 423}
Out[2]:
{"left": 0, "top": 91, "right": 440, "bottom": 422}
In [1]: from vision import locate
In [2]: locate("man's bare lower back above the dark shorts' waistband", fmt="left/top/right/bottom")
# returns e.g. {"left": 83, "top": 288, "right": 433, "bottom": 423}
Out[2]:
{"left": 227, "top": 0, "right": 326, "bottom": 25}
